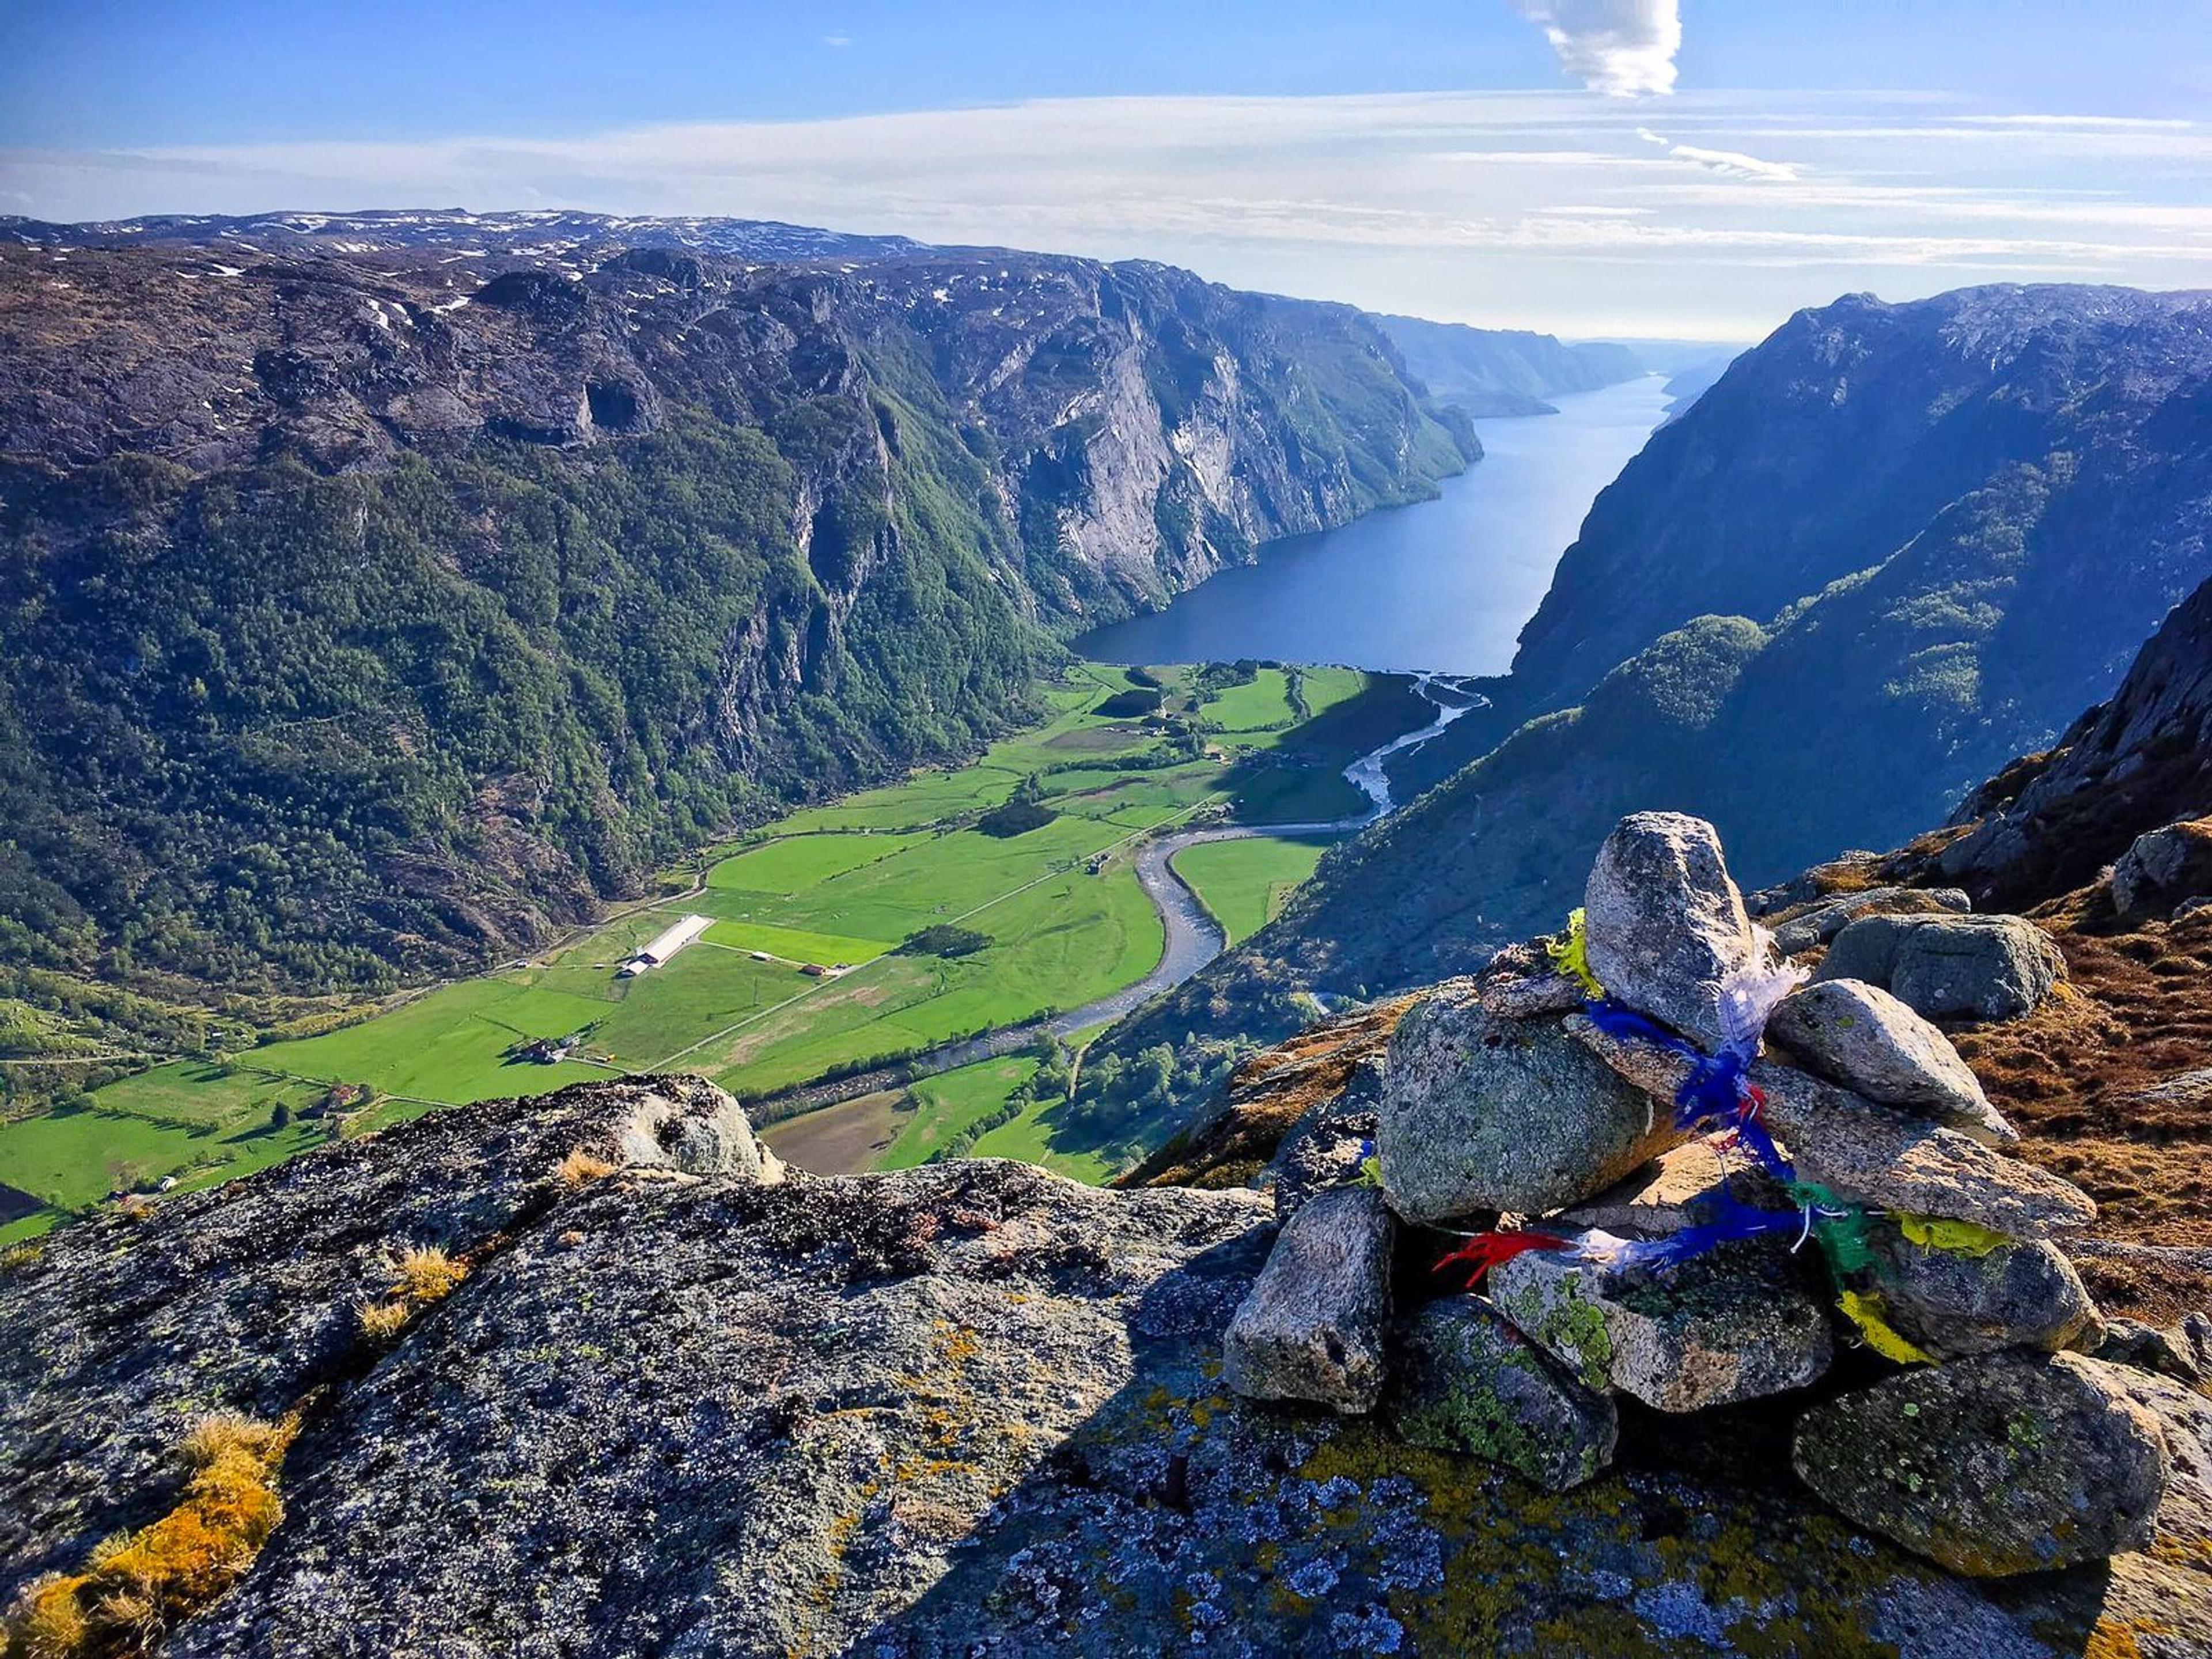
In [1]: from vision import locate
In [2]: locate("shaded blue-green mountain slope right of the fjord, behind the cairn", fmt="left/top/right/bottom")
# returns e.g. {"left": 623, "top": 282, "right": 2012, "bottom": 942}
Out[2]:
{"left": 1086, "top": 287, "right": 2212, "bottom": 1150}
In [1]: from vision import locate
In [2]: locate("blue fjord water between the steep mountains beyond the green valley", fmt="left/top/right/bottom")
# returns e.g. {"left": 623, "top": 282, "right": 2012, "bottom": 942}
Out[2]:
{"left": 1075, "top": 376, "right": 1666, "bottom": 675}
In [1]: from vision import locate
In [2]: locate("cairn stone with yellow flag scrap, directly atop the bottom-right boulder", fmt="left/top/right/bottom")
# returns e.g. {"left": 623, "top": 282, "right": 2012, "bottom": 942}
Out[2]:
{"left": 1867, "top": 1224, "right": 2097, "bottom": 1361}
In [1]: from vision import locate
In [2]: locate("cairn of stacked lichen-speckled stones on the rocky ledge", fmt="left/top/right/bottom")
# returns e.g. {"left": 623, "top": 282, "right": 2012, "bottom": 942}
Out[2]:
{"left": 1225, "top": 812, "right": 2170, "bottom": 1575}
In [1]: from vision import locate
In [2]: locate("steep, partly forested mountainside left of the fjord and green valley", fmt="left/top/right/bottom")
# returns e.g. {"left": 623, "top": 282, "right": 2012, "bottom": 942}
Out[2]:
{"left": 0, "top": 214, "right": 1475, "bottom": 988}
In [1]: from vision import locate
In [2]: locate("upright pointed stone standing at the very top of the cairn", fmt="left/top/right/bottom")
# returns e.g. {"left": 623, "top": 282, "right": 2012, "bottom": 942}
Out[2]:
{"left": 1582, "top": 812, "right": 1759, "bottom": 1048}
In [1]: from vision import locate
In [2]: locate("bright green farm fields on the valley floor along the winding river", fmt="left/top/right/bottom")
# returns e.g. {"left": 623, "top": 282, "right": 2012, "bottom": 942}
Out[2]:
{"left": 0, "top": 664, "right": 1420, "bottom": 1238}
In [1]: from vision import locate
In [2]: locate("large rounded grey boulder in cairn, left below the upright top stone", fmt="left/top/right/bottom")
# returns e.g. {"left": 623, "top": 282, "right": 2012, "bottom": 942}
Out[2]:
{"left": 1376, "top": 991, "right": 1683, "bottom": 1221}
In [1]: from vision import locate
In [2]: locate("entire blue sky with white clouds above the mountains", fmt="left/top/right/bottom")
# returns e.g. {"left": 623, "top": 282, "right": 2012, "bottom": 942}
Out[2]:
{"left": 0, "top": 0, "right": 2212, "bottom": 336}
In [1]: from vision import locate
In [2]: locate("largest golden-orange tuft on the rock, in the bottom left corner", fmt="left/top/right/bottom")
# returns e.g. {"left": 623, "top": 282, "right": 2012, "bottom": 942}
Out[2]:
{"left": 7, "top": 1414, "right": 298, "bottom": 1659}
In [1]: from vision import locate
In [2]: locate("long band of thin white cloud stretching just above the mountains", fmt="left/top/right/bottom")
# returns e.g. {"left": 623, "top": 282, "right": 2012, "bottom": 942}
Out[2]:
{"left": 0, "top": 90, "right": 2212, "bottom": 339}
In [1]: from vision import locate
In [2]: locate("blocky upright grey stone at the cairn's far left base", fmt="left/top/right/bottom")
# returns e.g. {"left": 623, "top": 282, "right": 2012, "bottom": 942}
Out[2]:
{"left": 1221, "top": 1185, "right": 1396, "bottom": 1411}
